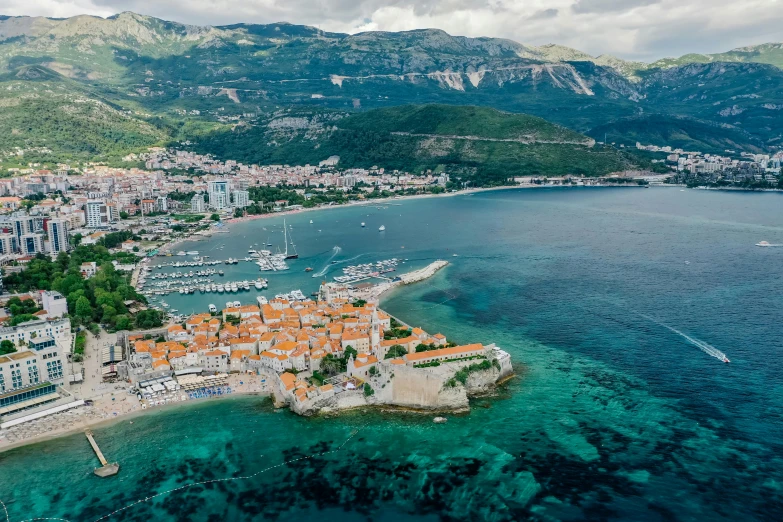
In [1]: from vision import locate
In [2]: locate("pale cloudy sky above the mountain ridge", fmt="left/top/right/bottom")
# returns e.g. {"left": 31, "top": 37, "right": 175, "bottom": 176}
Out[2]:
{"left": 0, "top": 0, "right": 783, "bottom": 60}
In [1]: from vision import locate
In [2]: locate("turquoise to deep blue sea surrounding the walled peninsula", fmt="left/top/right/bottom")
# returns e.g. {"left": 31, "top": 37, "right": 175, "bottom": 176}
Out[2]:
{"left": 0, "top": 188, "right": 783, "bottom": 522}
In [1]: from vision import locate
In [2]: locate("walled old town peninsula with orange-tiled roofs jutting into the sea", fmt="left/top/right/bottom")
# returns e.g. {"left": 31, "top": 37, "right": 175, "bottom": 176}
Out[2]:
{"left": 128, "top": 261, "right": 513, "bottom": 415}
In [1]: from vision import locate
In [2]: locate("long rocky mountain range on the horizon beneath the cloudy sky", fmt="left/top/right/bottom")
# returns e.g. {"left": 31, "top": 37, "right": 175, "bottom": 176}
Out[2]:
{"left": 0, "top": 13, "right": 783, "bottom": 174}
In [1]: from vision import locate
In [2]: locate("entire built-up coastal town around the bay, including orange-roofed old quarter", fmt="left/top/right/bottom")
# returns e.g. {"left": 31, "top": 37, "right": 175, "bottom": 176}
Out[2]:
{"left": 0, "top": 138, "right": 781, "bottom": 447}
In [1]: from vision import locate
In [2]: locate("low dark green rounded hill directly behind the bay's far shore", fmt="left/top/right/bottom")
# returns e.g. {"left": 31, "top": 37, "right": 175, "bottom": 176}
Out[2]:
{"left": 196, "top": 105, "right": 632, "bottom": 184}
